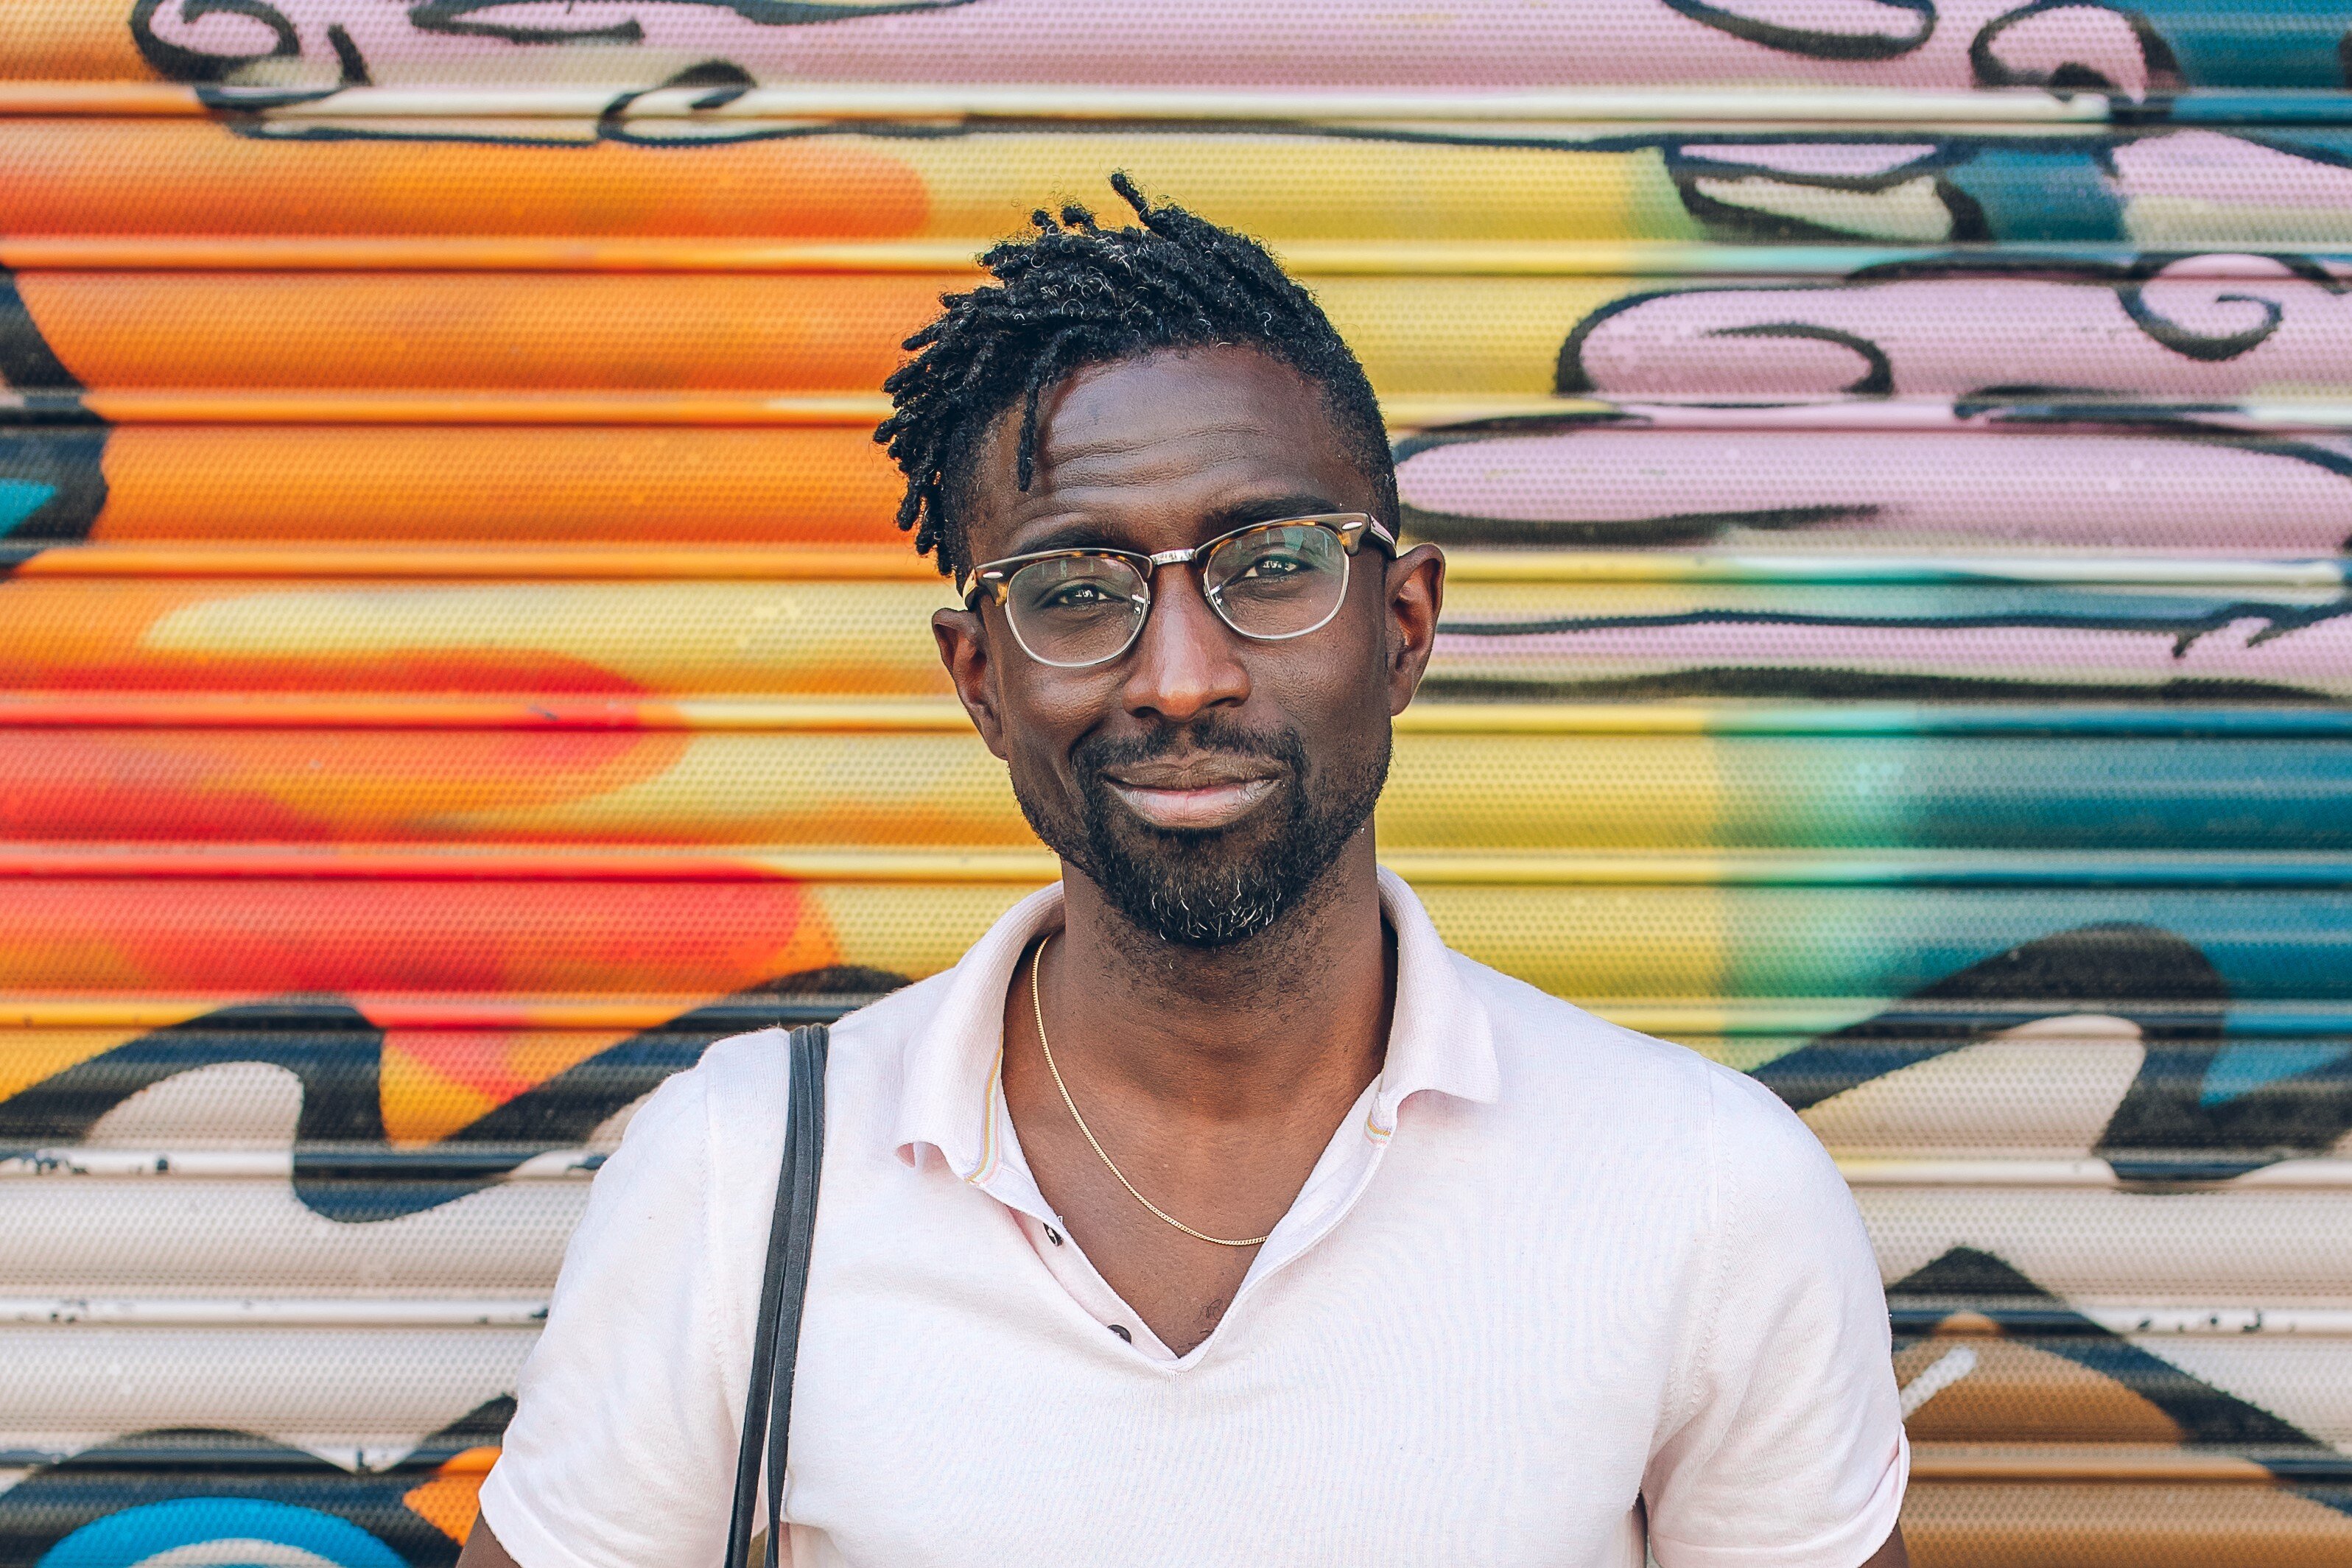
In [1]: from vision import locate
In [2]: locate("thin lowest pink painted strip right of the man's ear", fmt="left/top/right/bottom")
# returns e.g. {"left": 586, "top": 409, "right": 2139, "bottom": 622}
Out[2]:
{"left": 1437, "top": 602, "right": 2352, "bottom": 696}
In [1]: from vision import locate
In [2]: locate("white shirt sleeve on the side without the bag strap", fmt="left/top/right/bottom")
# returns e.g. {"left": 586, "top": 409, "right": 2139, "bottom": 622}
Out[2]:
{"left": 1642, "top": 1072, "right": 1910, "bottom": 1568}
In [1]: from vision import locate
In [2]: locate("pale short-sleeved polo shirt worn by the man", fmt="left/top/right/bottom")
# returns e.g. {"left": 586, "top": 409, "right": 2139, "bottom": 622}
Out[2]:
{"left": 482, "top": 872, "right": 1910, "bottom": 1568}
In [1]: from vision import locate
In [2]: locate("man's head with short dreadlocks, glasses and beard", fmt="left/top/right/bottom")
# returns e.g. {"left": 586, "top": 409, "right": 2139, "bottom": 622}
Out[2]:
{"left": 877, "top": 179, "right": 1442, "bottom": 947}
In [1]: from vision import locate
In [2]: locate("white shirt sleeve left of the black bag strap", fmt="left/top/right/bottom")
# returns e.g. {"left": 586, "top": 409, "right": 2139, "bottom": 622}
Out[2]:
{"left": 482, "top": 1037, "right": 783, "bottom": 1568}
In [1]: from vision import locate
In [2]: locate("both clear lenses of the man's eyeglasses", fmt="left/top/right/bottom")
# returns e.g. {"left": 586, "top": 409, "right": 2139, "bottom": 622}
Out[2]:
{"left": 1004, "top": 522, "right": 1348, "bottom": 668}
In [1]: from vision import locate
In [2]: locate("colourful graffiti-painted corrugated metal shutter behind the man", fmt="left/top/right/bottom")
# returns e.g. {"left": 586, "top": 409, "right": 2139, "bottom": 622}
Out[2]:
{"left": 0, "top": 0, "right": 2352, "bottom": 1568}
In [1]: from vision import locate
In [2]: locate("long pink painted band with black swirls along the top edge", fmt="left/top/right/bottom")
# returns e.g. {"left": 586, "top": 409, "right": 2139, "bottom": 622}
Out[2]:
{"left": 137, "top": 0, "right": 2163, "bottom": 89}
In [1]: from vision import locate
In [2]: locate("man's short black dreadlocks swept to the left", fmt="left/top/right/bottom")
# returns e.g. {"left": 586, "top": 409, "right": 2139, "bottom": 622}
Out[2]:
{"left": 875, "top": 172, "right": 1397, "bottom": 574}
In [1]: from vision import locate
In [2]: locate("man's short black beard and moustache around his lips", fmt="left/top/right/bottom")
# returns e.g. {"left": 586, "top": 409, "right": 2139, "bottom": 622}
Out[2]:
{"left": 1014, "top": 720, "right": 1390, "bottom": 947}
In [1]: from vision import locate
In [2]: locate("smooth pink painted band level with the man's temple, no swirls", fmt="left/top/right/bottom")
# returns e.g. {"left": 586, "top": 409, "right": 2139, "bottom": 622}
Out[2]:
{"left": 1397, "top": 428, "right": 2352, "bottom": 555}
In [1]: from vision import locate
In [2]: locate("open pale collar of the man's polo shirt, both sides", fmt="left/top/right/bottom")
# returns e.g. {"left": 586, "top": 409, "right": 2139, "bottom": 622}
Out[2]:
{"left": 896, "top": 868, "right": 1500, "bottom": 1180}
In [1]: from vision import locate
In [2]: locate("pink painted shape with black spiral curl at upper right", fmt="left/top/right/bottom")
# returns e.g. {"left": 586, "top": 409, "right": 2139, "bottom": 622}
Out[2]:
{"left": 1571, "top": 256, "right": 2352, "bottom": 397}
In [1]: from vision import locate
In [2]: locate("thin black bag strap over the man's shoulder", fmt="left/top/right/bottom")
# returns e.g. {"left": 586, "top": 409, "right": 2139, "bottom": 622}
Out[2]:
{"left": 727, "top": 1022, "right": 830, "bottom": 1568}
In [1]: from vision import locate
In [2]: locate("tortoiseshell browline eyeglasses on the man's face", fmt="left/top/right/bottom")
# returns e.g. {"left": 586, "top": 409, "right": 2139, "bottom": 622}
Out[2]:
{"left": 964, "top": 513, "right": 1397, "bottom": 670}
